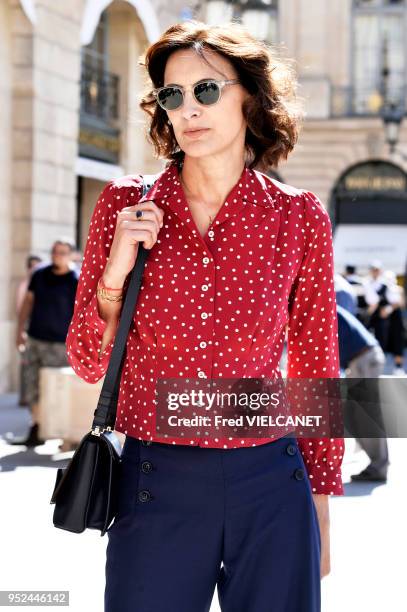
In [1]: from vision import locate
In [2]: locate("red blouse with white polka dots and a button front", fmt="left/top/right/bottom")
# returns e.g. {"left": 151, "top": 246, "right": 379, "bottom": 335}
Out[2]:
{"left": 66, "top": 162, "right": 344, "bottom": 495}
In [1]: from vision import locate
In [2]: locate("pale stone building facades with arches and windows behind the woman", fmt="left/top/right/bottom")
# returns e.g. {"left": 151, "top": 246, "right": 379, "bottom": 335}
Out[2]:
{"left": 0, "top": 0, "right": 407, "bottom": 390}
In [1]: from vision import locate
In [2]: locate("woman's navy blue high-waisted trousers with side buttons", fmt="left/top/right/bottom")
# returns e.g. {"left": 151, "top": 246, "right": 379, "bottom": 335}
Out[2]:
{"left": 105, "top": 434, "right": 321, "bottom": 612}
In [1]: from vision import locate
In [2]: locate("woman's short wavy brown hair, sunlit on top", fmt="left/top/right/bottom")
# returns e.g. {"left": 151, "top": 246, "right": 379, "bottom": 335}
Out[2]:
{"left": 139, "top": 19, "right": 302, "bottom": 171}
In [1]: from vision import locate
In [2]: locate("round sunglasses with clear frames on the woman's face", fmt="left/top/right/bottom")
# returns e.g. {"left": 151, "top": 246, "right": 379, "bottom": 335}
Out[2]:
{"left": 152, "top": 79, "right": 240, "bottom": 110}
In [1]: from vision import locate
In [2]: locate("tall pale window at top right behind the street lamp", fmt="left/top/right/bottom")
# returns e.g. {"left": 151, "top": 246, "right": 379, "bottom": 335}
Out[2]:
{"left": 353, "top": 0, "right": 406, "bottom": 114}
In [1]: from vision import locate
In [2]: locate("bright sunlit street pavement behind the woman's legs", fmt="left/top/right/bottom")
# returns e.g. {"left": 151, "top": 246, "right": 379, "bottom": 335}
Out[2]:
{"left": 0, "top": 394, "right": 407, "bottom": 612}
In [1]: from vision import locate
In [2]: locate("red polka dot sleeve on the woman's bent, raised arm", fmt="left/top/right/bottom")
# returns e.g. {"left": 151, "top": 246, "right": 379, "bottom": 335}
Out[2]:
{"left": 66, "top": 180, "right": 141, "bottom": 383}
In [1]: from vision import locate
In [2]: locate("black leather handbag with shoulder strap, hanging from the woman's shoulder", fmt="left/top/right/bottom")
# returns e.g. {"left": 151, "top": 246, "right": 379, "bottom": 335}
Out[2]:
{"left": 50, "top": 173, "right": 161, "bottom": 536}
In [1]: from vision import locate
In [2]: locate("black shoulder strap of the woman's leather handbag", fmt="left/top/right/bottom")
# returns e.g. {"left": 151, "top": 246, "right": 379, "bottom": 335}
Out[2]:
{"left": 92, "top": 172, "right": 161, "bottom": 430}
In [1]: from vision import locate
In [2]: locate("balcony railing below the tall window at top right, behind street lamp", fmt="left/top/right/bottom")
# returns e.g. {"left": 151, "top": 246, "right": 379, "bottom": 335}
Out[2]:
{"left": 331, "top": 85, "right": 407, "bottom": 117}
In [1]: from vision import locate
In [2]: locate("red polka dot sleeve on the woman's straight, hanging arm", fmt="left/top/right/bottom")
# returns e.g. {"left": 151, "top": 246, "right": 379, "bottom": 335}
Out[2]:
{"left": 287, "top": 191, "right": 345, "bottom": 495}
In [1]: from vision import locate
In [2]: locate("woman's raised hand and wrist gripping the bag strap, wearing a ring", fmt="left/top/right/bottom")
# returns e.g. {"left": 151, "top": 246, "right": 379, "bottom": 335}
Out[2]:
{"left": 103, "top": 200, "right": 164, "bottom": 287}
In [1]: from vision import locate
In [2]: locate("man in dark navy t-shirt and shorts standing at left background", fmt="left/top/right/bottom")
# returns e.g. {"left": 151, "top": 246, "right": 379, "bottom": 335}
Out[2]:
{"left": 8, "top": 238, "right": 79, "bottom": 446}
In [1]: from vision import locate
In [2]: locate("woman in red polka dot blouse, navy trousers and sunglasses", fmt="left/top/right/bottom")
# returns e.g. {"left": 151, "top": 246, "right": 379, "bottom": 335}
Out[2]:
{"left": 67, "top": 21, "right": 343, "bottom": 612}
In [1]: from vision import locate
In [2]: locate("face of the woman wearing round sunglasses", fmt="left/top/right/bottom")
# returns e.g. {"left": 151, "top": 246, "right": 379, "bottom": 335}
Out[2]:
{"left": 164, "top": 49, "right": 248, "bottom": 157}
